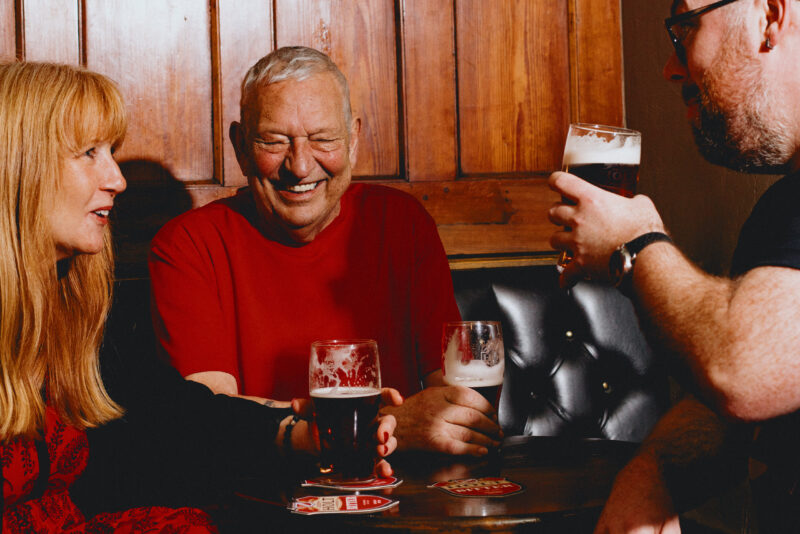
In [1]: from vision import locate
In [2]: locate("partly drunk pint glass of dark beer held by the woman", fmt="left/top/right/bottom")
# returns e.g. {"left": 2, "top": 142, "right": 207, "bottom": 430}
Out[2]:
{"left": 308, "top": 339, "right": 381, "bottom": 482}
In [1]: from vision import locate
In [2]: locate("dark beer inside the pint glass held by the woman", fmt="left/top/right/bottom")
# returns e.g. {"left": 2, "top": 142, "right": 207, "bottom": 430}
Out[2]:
{"left": 311, "top": 387, "right": 380, "bottom": 480}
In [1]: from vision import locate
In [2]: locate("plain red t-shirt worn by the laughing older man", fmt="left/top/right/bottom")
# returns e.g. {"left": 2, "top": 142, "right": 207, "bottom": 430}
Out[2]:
{"left": 150, "top": 184, "right": 459, "bottom": 400}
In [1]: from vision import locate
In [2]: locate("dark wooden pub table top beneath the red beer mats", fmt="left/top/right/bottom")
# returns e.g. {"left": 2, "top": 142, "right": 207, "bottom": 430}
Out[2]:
{"left": 230, "top": 436, "right": 637, "bottom": 534}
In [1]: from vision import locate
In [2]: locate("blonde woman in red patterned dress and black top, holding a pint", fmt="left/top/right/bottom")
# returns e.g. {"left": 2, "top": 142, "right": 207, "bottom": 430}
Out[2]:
{"left": 0, "top": 63, "right": 396, "bottom": 532}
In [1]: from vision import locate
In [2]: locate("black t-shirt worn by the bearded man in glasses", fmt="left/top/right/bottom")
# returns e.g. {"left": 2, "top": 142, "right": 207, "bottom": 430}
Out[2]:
{"left": 731, "top": 174, "right": 800, "bottom": 532}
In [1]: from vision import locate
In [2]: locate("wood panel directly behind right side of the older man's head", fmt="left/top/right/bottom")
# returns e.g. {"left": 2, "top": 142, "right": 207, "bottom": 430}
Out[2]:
{"left": 275, "top": 0, "right": 401, "bottom": 177}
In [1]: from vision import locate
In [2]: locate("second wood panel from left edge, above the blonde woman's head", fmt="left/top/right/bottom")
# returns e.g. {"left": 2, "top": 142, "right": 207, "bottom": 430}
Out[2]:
{"left": 21, "top": 0, "right": 80, "bottom": 65}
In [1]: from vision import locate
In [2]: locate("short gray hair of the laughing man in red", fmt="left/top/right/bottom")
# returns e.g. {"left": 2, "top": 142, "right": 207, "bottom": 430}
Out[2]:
{"left": 239, "top": 46, "right": 353, "bottom": 130}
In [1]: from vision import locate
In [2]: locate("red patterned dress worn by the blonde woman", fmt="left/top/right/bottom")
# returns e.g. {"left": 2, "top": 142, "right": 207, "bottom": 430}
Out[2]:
{"left": 0, "top": 408, "right": 217, "bottom": 534}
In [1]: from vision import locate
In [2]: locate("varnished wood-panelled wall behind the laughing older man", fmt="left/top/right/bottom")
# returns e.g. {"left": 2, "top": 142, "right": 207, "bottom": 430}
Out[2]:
{"left": 0, "top": 0, "right": 624, "bottom": 276}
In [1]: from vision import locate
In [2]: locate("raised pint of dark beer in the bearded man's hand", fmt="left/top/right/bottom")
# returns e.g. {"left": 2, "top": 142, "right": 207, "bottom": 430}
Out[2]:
{"left": 558, "top": 123, "right": 642, "bottom": 269}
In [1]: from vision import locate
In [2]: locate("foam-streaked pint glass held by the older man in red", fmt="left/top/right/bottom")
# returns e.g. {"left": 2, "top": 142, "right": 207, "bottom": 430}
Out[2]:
{"left": 442, "top": 321, "right": 506, "bottom": 411}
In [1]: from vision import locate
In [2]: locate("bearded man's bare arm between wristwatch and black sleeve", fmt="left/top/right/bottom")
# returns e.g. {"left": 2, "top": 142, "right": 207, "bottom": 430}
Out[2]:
{"left": 634, "top": 243, "right": 800, "bottom": 421}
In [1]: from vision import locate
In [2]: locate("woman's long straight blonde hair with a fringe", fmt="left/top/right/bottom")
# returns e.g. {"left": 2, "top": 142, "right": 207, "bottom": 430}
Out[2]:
{"left": 0, "top": 63, "right": 127, "bottom": 442}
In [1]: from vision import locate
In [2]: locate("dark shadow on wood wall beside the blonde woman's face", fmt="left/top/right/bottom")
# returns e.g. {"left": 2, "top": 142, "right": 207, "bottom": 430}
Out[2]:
{"left": 113, "top": 160, "right": 192, "bottom": 279}
